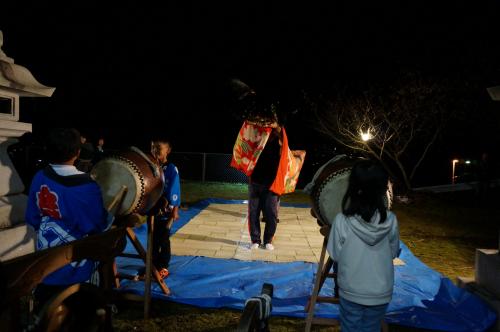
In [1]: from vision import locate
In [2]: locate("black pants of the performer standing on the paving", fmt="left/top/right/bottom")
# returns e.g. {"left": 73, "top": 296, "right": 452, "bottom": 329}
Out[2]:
{"left": 248, "top": 183, "right": 279, "bottom": 244}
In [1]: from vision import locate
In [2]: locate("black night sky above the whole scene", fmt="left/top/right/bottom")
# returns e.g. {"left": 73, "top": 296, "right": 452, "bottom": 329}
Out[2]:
{"left": 0, "top": 0, "right": 500, "bottom": 182}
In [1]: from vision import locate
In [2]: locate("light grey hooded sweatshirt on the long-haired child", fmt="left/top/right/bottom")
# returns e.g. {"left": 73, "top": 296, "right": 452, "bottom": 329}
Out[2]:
{"left": 327, "top": 211, "right": 399, "bottom": 305}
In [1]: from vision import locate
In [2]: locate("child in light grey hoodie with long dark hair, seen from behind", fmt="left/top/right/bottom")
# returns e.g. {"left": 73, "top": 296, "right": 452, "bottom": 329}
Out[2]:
{"left": 327, "top": 160, "right": 399, "bottom": 332}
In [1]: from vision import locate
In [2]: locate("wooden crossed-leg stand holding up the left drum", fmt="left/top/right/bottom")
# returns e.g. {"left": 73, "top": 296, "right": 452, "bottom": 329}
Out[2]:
{"left": 107, "top": 186, "right": 170, "bottom": 319}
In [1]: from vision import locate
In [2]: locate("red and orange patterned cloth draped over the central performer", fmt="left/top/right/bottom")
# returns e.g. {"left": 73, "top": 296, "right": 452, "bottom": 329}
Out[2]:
{"left": 231, "top": 121, "right": 306, "bottom": 195}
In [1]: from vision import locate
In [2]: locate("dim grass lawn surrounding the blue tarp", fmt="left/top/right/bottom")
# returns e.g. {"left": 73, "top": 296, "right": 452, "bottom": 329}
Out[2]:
{"left": 114, "top": 182, "right": 500, "bottom": 332}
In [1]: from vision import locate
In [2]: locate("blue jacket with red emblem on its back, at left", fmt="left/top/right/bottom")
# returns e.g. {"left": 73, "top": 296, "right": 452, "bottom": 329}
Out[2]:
{"left": 26, "top": 166, "right": 108, "bottom": 285}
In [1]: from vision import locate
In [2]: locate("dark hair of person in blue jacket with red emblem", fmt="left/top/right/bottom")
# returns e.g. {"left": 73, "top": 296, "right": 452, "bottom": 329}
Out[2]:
{"left": 47, "top": 128, "right": 82, "bottom": 163}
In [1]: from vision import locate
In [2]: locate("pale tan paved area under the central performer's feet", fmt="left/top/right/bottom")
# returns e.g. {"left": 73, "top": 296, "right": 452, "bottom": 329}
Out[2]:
{"left": 171, "top": 204, "right": 323, "bottom": 262}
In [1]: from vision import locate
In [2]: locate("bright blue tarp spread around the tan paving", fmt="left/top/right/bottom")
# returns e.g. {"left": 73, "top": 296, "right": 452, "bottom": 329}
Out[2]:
{"left": 117, "top": 199, "right": 496, "bottom": 331}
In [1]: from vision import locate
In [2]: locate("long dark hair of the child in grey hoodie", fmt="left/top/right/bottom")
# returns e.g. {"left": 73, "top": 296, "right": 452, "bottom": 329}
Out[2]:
{"left": 342, "top": 160, "right": 389, "bottom": 223}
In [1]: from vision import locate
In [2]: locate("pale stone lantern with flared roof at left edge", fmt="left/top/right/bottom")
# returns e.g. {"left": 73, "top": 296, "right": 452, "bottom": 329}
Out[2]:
{"left": 0, "top": 31, "right": 55, "bottom": 261}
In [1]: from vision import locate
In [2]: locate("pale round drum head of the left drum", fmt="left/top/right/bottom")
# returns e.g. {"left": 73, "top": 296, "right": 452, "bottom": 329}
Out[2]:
{"left": 91, "top": 158, "right": 144, "bottom": 215}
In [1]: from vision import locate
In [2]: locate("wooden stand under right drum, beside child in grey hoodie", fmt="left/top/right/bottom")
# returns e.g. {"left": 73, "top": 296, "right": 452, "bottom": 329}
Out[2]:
{"left": 304, "top": 225, "right": 389, "bottom": 332}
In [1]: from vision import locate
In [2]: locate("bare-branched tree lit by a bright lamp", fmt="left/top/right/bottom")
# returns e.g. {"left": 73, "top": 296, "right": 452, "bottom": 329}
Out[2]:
{"left": 309, "top": 76, "right": 470, "bottom": 190}
